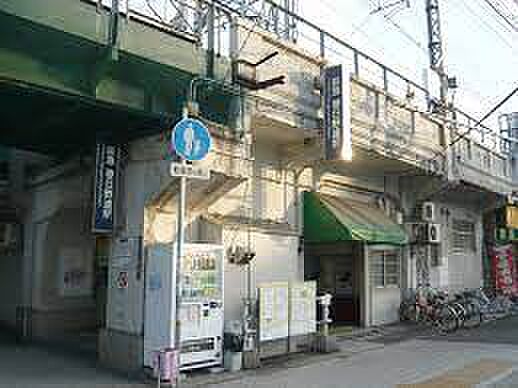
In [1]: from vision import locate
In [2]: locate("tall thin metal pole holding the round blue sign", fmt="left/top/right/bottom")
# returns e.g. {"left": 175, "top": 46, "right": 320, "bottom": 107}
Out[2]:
{"left": 174, "top": 108, "right": 188, "bottom": 387}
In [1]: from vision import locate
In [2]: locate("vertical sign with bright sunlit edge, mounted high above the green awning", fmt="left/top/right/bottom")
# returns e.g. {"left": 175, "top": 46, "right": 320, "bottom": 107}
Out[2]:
{"left": 324, "top": 65, "right": 352, "bottom": 160}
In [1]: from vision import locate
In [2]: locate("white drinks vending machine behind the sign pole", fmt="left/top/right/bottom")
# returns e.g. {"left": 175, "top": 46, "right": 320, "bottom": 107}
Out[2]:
{"left": 144, "top": 244, "right": 224, "bottom": 370}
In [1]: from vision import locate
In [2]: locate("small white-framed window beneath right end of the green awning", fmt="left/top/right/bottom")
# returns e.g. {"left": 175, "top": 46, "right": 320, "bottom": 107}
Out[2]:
{"left": 369, "top": 249, "right": 401, "bottom": 287}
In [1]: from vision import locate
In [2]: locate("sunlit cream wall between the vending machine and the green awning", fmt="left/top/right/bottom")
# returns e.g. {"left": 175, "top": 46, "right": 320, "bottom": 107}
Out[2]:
{"left": 208, "top": 140, "right": 311, "bottom": 320}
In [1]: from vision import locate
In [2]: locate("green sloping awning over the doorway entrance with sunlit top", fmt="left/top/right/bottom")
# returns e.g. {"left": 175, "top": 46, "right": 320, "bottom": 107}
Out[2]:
{"left": 304, "top": 192, "right": 408, "bottom": 245}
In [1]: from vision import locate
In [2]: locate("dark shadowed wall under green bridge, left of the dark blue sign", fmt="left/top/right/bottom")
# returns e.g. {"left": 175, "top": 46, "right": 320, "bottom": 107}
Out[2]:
{"left": 24, "top": 163, "right": 96, "bottom": 338}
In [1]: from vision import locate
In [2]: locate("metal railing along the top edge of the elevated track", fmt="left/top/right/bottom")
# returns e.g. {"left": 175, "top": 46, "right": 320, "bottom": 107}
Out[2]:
{"left": 91, "top": 0, "right": 510, "bottom": 157}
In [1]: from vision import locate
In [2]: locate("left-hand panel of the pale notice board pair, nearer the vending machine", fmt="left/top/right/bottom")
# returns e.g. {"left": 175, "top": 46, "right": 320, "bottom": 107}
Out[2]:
{"left": 259, "top": 282, "right": 289, "bottom": 342}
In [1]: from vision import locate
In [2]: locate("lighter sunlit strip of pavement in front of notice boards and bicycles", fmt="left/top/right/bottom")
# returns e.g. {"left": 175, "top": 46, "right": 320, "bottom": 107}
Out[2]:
{"left": 209, "top": 340, "right": 518, "bottom": 388}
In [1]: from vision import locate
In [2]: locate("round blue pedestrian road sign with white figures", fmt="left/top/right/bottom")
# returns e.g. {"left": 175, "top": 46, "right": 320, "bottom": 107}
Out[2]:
{"left": 171, "top": 118, "right": 212, "bottom": 162}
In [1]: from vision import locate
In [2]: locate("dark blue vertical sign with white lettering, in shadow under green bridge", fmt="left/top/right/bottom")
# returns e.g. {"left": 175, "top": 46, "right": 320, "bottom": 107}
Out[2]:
{"left": 92, "top": 144, "right": 120, "bottom": 233}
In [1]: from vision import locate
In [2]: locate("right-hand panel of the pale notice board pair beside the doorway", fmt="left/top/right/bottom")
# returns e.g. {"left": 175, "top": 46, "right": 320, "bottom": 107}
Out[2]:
{"left": 289, "top": 281, "right": 317, "bottom": 336}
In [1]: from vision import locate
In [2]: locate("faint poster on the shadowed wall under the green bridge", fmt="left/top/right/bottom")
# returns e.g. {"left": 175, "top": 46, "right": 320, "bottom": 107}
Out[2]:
{"left": 58, "top": 247, "right": 93, "bottom": 297}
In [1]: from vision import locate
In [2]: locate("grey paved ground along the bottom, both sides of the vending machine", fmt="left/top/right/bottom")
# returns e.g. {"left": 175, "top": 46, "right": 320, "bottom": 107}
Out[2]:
{"left": 0, "top": 317, "right": 518, "bottom": 388}
